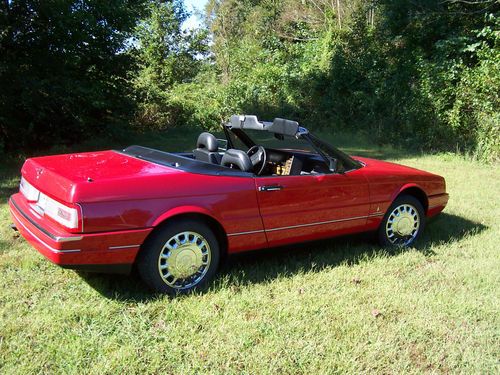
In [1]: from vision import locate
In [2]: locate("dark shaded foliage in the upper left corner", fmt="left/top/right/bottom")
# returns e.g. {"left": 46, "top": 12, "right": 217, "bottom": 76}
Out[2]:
{"left": 0, "top": 0, "right": 142, "bottom": 150}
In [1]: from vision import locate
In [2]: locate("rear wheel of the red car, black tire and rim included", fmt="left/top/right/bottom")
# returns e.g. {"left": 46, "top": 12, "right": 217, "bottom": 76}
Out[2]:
{"left": 137, "top": 219, "right": 220, "bottom": 296}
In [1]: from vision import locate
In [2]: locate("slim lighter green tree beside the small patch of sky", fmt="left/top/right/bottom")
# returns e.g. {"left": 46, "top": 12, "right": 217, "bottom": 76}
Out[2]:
{"left": 131, "top": 0, "right": 207, "bottom": 128}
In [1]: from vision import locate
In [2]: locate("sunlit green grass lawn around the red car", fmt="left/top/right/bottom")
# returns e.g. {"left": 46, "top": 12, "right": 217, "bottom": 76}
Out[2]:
{"left": 0, "top": 131, "right": 500, "bottom": 374}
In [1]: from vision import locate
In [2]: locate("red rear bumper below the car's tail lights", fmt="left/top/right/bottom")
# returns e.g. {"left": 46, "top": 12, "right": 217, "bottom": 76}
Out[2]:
{"left": 9, "top": 193, "right": 152, "bottom": 273}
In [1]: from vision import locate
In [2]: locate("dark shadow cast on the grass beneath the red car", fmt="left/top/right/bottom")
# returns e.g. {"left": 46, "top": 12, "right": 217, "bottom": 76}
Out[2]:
{"left": 79, "top": 213, "right": 487, "bottom": 302}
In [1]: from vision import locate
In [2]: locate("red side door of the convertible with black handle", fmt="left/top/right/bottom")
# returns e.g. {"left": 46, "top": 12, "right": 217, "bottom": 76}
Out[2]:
{"left": 255, "top": 168, "right": 370, "bottom": 246}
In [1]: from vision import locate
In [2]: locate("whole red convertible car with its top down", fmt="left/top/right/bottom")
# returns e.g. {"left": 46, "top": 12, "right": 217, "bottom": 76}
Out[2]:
{"left": 9, "top": 116, "right": 448, "bottom": 294}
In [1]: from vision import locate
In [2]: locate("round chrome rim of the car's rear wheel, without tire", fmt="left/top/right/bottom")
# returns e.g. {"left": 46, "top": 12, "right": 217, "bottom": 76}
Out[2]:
{"left": 158, "top": 231, "right": 212, "bottom": 290}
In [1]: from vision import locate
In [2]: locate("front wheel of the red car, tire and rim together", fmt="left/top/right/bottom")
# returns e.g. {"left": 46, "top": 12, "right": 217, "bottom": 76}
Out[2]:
{"left": 379, "top": 195, "right": 425, "bottom": 246}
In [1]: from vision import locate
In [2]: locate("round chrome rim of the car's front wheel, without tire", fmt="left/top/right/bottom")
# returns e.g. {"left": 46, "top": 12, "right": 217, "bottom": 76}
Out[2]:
{"left": 385, "top": 203, "right": 420, "bottom": 246}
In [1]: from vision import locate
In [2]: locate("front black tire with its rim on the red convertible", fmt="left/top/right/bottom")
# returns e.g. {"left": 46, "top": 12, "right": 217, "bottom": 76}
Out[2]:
{"left": 378, "top": 195, "right": 425, "bottom": 247}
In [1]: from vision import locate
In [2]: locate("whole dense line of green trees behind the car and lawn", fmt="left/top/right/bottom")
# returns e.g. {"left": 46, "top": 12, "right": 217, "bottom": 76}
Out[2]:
{"left": 0, "top": 0, "right": 500, "bottom": 160}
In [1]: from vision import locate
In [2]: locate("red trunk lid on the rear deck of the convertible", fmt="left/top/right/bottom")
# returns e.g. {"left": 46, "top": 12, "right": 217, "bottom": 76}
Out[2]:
{"left": 21, "top": 151, "right": 186, "bottom": 203}
